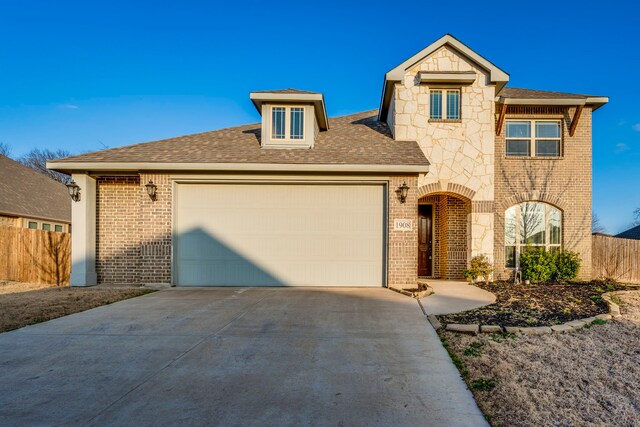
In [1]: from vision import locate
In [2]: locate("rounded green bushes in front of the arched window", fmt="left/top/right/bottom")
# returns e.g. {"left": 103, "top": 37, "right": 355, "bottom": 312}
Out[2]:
{"left": 520, "top": 247, "right": 580, "bottom": 282}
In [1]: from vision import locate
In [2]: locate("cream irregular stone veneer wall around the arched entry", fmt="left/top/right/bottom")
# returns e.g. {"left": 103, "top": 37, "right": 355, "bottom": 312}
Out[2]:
{"left": 393, "top": 46, "right": 495, "bottom": 266}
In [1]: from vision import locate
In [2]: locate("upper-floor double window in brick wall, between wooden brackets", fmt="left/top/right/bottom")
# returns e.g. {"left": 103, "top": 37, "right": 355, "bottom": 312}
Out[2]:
{"left": 505, "top": 120, "right": 562, "bottom": 157}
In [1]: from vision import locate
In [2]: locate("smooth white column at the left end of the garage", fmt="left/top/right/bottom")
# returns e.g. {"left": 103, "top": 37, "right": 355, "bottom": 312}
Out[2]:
{"left": 69, "top": 173, "right": 98, "bottom": 286}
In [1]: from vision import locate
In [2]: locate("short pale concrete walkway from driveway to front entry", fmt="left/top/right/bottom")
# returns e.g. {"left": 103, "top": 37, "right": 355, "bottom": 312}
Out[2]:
{"left": 420, "top": 279, "right": 496, "bottom": 314}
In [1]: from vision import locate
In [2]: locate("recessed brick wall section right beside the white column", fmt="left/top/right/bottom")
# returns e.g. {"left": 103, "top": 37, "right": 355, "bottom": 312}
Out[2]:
{"left": 96, "top": 176, "right": 140, "bottom": 284}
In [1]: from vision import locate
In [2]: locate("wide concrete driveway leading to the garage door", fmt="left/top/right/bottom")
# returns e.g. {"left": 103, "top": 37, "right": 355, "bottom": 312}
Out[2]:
{"left": 0, "top": 288, "right": 486, "bottom": 426}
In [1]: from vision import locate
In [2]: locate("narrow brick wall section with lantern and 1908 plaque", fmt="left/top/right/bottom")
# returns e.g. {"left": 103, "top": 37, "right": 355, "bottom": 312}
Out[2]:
{"left": 388, "top": 175, "right": 418, "bottom": 288}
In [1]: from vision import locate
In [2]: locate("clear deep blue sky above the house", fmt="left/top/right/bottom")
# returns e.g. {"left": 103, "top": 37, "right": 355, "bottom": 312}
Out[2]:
{"left": 0, "top": 0, "right": 640, "bottom": 232}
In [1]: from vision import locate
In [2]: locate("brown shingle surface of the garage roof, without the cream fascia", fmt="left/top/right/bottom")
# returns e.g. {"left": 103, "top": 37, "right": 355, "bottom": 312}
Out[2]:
{"left": 56, "top": 110, "right": 429, "bottom": 166}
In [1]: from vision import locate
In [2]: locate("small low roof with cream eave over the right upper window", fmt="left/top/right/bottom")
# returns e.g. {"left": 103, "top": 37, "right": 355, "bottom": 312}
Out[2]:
{"left": 497, "top": 87, "right": 609, "bottom": 110}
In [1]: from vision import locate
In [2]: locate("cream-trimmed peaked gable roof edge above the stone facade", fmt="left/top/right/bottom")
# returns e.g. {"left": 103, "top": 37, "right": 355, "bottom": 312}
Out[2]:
{"left": 378, "top": 34, "right": 509, "bottom": 120}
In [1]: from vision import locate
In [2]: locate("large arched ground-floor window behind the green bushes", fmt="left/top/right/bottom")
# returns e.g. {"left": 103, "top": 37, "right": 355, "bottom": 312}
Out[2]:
{"left": 504, "top": 202, "right": 562, "bottom": 268}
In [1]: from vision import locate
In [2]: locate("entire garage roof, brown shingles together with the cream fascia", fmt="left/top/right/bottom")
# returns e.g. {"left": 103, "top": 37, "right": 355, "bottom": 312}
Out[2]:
{"left": 48, "top": 110, "right": 429, "bottom": 172}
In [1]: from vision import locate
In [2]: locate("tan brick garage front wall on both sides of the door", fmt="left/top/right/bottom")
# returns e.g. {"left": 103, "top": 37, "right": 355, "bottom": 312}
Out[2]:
{"left": 96, "top": 174, "right": 418, "bottom": 287}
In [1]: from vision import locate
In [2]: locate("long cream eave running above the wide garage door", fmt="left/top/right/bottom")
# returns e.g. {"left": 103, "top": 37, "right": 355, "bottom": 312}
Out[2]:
{"left": 47, "top": 159, "right": 429, "bottom": 173}
